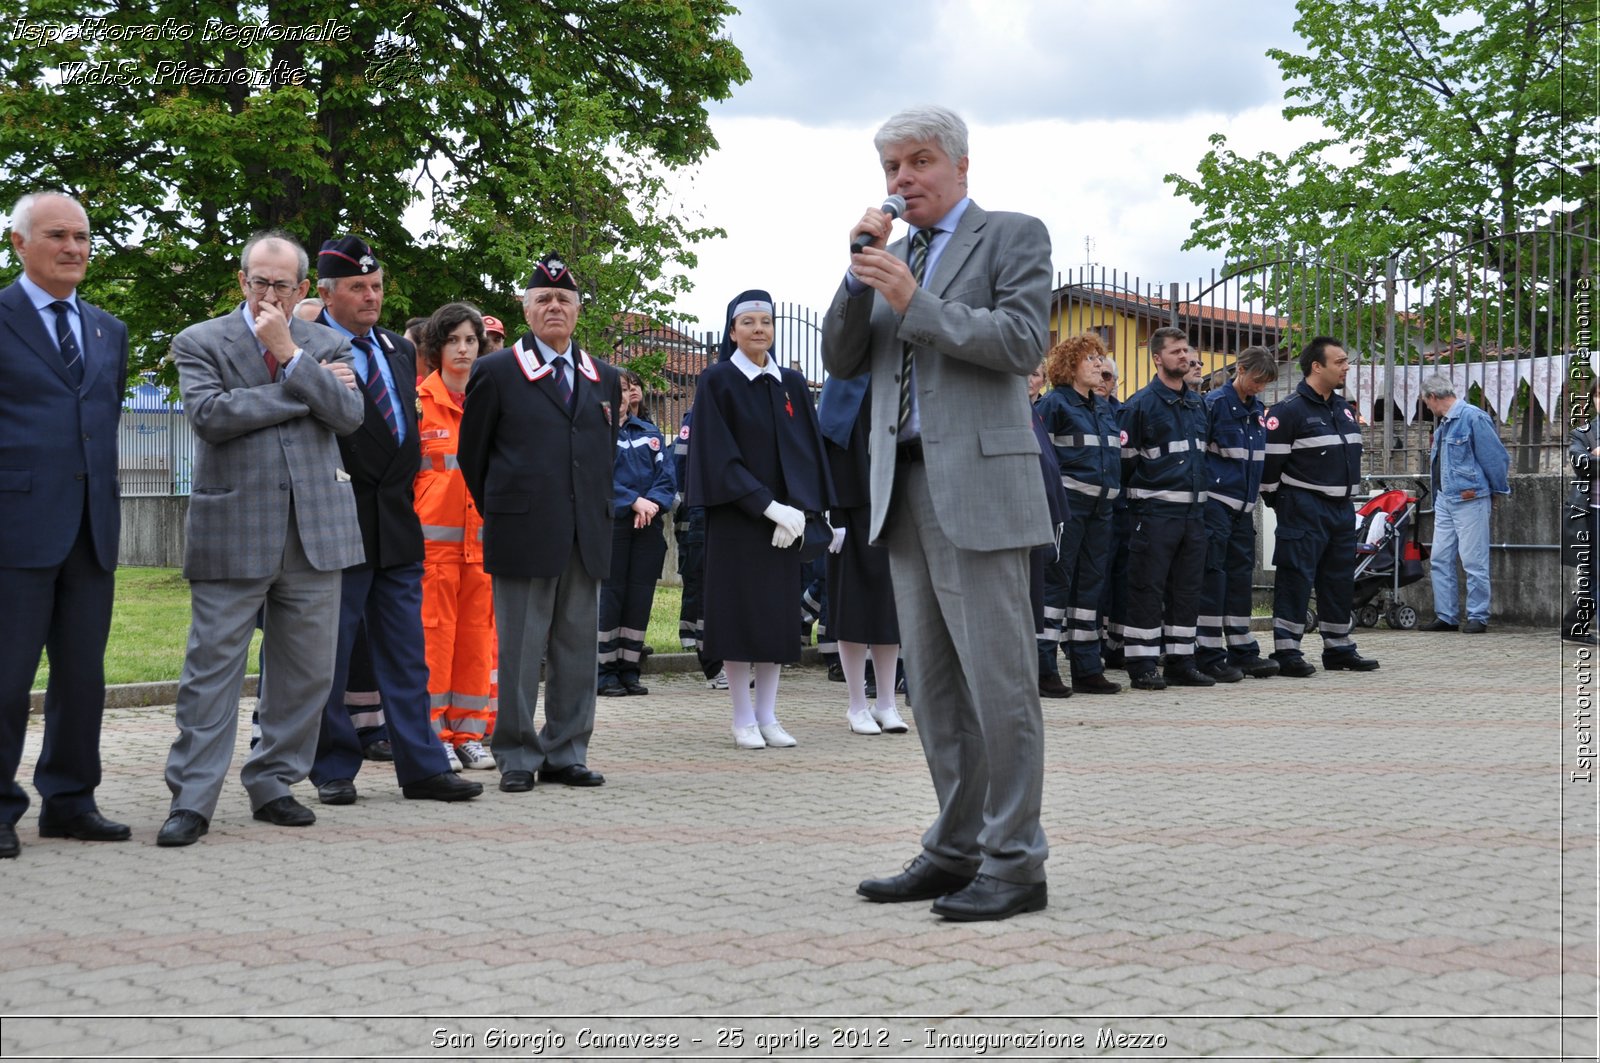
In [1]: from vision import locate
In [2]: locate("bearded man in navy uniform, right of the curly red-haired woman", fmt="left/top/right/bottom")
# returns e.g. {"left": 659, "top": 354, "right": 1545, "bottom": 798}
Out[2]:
{"left": 1120, "top": 328, "right": 1216, "bottom": 690}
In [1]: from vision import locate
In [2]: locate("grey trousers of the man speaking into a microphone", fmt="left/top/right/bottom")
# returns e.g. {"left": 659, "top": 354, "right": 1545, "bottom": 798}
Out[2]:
{"left": 885, "top": 461, "right": 1050, "bottom": 882}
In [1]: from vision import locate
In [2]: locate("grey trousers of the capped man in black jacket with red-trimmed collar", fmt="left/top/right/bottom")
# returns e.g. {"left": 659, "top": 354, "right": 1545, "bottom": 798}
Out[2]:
{"left": 490, "top": 543, "right": 600, "bottom": 772}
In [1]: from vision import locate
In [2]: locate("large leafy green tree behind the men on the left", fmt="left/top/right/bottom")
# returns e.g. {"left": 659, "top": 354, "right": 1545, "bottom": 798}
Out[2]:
{"left": 0, "top": 0, "right": 749, "bottom": 382}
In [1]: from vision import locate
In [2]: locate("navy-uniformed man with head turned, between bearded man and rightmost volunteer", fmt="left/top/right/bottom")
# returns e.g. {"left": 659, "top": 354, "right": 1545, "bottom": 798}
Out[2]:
{"left": 1195, "top": 347, "right": 1278, "bottom": 684}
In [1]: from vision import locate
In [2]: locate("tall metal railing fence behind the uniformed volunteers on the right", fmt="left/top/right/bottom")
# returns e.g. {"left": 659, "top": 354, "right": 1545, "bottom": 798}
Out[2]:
{"left": 1051, "top": 215, "right": 1597, "bottom": 475}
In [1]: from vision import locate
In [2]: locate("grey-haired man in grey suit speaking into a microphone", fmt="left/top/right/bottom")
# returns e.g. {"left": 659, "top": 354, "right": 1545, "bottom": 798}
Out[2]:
{"left": 822, "top": 107, "right": 1051, "bottom": 921}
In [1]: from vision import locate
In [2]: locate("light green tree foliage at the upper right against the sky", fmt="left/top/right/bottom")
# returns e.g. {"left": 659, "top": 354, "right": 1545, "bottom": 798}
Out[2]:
{"left": 1166, "top": 0, "right": 1600, "bottom": 261}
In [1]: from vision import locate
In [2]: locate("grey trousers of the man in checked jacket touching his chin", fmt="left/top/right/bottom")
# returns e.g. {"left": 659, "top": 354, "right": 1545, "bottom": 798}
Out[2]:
{"left": 166, "top": 506, "right": 341, "bottom": 821}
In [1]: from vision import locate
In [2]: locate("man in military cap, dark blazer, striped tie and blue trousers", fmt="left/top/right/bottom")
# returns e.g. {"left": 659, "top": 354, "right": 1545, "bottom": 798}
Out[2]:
{"left": 310, "top": 237, "right": 483, "bottom": 805}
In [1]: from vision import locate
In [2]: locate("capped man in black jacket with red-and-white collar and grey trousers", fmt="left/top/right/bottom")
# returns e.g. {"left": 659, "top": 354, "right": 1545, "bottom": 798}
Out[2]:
{"left": 458, "top": 255, "right": 622, "bottom": 792}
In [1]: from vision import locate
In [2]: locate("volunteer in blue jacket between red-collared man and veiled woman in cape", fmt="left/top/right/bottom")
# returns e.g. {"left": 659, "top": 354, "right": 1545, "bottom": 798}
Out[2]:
{"left": 600, "top": 370, "right": 674, "bottom": 698}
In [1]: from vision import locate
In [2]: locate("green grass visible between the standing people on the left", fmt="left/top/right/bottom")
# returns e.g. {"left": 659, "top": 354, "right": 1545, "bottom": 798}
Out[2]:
{"left": 34, "top": 567, "right": 683, "bottom": 690}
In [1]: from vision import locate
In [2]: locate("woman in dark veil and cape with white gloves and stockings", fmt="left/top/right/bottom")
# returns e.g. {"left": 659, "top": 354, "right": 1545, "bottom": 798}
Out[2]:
{"left": 686, "top": 291, "right": 832, "bottom": 749}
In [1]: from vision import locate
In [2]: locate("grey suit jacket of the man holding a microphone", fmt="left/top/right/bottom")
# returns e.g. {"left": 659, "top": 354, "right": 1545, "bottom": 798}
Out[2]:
{"left": 822, "top": 203, "right": 1051, "bottom": 551}
